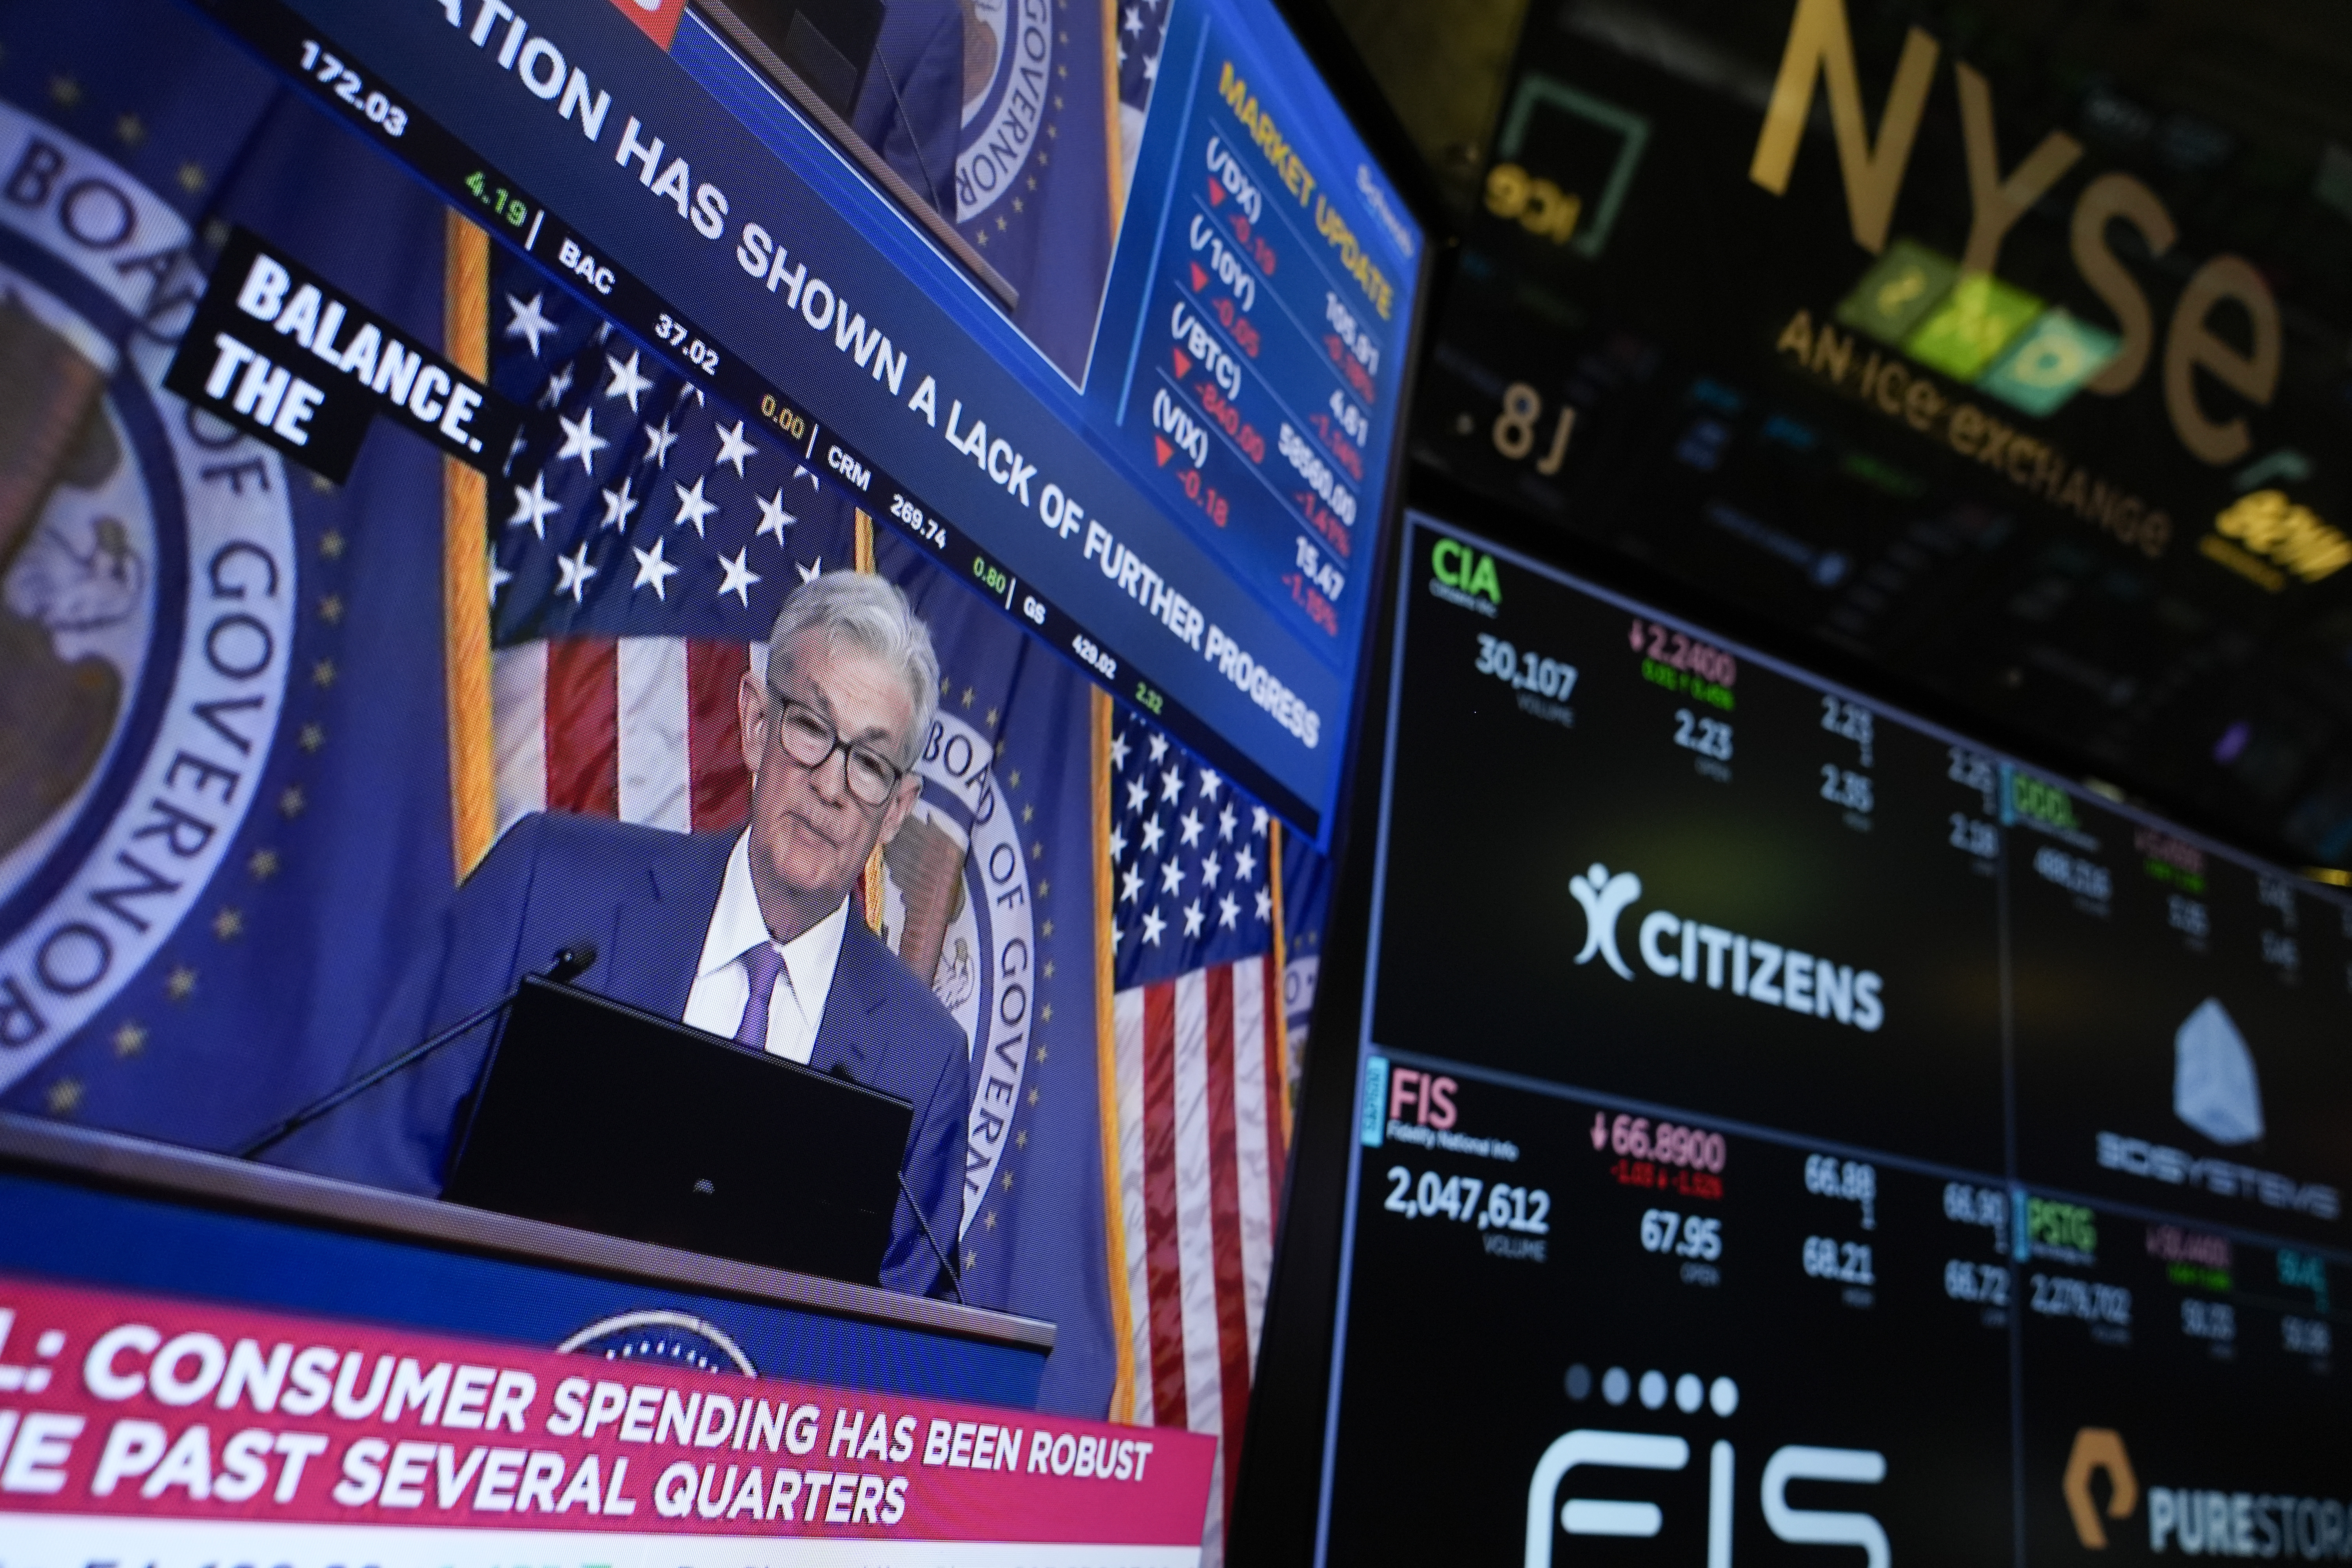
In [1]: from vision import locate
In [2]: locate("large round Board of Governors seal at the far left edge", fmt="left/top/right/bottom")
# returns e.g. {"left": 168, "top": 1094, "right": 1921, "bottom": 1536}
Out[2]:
{"left": 0, "top": 103, "right": 296, "bottom": 1089}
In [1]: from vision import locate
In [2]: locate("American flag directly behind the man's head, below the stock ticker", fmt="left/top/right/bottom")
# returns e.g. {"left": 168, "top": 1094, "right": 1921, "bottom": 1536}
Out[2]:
{"left": 475, "top": 263, "right": 851, "bottom": 832}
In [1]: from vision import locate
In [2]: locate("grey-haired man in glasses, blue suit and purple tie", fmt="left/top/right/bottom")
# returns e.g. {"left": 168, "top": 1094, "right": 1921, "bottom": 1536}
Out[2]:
{"left": 275, "top": 571, "right": 967, "bottom": 1293}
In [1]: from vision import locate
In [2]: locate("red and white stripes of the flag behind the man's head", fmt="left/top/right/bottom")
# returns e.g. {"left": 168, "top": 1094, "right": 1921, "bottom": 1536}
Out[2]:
{"left": 492, "top": 637, "right": 767, "bottom": 832}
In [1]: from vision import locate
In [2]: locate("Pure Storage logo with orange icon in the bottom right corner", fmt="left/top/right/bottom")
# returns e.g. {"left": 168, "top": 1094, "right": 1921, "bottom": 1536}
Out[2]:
{"left": 2065, "top": 1427, "right": 2352, "bottom": 1563}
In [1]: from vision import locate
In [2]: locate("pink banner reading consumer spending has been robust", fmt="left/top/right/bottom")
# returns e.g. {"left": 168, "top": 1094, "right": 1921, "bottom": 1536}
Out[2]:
{"left": 0, "top": 1279, "right": 1216, "bottom": 1568}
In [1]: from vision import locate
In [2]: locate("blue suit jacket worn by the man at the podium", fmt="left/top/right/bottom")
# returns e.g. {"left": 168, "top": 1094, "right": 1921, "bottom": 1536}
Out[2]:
{"left": 270, "top": 813, "right": 967, "bottom": 1293}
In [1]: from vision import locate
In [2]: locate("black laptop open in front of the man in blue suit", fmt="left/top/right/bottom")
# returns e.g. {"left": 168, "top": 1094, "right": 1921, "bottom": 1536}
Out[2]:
{"left": 442, "top": 978, "right": 915, "bottom": 1286}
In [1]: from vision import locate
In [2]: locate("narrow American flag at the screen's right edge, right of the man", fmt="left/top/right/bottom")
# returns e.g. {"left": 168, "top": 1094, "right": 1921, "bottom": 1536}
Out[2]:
{"left": 1103, "top": 715, "right": 1287, "bottom": 1507}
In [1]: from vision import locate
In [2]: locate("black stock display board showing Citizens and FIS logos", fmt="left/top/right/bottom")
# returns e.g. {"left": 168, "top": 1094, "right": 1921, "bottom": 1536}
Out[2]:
{"left": 1277, "top": 512, "right": 2352, "bottom": 1568}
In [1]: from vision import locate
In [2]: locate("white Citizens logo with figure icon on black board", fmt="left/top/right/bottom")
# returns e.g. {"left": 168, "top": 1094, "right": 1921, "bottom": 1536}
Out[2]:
{"left": 1569, "top": 860, "right": 1886, "bottom": 1032}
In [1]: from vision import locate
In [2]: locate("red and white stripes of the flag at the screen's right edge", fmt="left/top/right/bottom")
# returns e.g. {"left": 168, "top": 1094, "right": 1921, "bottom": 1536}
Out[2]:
{"left": 1110, "top": 952, "right": 1284, "bottom": 1507}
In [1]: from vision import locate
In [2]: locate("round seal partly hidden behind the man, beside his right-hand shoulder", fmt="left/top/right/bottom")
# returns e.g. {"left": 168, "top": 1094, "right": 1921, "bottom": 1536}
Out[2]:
{"left": 882, "top": 712, "right": 1037, "bottom": 1229}
